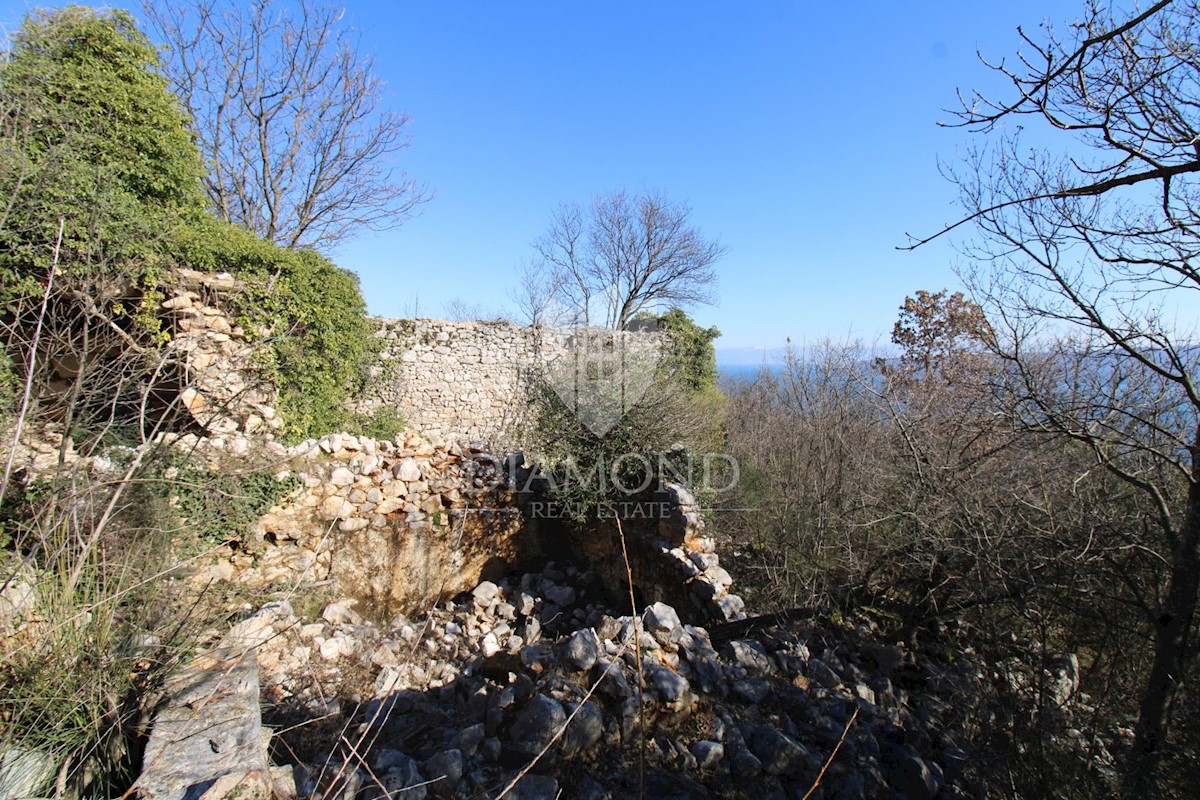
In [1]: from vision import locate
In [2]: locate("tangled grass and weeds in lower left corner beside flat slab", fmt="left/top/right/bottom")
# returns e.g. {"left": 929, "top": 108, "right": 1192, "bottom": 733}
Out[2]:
{"left": 0, "top": 474, "right": 204, "bottom": 798}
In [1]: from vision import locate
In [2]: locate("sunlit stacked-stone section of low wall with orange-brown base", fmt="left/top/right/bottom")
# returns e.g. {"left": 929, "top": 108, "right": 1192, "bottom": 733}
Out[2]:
{"left": 190, "top": 432, "right": 522, "bottom": 610}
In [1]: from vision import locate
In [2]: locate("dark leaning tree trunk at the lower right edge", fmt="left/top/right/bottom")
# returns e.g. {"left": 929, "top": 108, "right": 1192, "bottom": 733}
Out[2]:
{"left": 1124, "top": 434, "right": 1200, "bottom": 798}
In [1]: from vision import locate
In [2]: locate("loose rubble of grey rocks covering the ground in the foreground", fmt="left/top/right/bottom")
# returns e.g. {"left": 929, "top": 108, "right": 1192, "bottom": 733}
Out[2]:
{"left": 206, "top": 556, "right": 988, "bottom": 800}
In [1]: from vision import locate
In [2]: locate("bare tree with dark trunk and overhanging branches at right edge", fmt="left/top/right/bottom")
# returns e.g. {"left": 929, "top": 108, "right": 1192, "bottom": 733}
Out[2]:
{"left": 913, "top": 0, "right": 1200, "bottom": 795}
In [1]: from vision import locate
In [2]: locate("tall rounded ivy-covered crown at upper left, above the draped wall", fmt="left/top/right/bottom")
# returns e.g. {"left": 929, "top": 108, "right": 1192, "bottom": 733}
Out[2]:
{"left": 0, "top": 6, "right": 204, "bottom": 302}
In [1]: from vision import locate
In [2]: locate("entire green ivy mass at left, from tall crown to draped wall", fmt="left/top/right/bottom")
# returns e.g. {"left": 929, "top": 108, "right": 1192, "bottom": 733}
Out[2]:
{"left": 0, "top": 6, "right": 374, "bottom": 438}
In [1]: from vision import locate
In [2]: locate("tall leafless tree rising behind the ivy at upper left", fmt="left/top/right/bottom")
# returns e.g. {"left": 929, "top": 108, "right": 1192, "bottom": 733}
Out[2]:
{"left": 143, "top": 0, "right": 427, "bottom": 248}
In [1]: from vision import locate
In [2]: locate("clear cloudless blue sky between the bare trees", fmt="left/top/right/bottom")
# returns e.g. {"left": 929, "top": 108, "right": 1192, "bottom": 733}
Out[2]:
{"left": 0, "top": 0, "right": 1084, "bottom": 362}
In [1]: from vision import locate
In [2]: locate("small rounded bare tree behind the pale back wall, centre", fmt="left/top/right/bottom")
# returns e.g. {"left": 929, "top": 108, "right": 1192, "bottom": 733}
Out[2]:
{"left": 534, "top": 192, "right": 725, "bottom": 330}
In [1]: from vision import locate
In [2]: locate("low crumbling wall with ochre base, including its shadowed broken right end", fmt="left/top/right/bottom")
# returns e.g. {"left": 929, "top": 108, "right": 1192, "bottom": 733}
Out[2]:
{"left": 206, "top": 433, "right": 743, "bottom": 622}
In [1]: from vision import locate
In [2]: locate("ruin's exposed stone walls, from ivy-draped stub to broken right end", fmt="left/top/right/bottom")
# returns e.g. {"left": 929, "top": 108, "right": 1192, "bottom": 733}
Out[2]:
{"left": 14, "top": 293, "right": 740, "bottom": 621}
